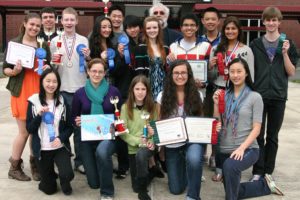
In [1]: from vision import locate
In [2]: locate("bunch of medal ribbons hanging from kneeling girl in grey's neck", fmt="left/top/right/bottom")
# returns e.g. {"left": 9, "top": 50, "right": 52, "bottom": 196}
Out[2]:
{"left": 222, "top": 86, "right": 251, "bottom": 136}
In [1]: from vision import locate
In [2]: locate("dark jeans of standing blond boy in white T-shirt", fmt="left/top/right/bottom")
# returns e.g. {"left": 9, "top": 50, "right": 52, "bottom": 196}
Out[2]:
{"left": 61, "top": 91, "right": 82, "bottom": 168}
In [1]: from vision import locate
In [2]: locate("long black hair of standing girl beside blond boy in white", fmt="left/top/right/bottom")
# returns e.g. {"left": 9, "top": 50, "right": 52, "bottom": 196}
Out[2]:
{"left": 89, "top": 16, "right": 114, "bottom": 58}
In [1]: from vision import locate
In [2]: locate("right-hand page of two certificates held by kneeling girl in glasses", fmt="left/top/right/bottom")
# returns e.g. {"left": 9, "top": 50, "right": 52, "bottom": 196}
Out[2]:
{"left": 184, "top": 117, "right": 215, "bottom": 144}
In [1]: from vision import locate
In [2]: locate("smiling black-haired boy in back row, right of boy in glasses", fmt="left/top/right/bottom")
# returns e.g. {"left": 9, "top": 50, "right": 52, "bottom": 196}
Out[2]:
{"left": 199, "top": 7, "right": 221, "bottom": 174}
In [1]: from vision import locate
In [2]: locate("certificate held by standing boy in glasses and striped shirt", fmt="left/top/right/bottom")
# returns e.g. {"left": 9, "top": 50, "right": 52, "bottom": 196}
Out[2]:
{"left": 188, "top": 60, "right": 207, "bottom": 82}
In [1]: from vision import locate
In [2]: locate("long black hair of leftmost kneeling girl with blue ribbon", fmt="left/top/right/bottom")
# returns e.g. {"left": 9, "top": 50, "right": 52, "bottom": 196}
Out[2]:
{"left": 39, "top": 68, "right": 61, "bottom": 106}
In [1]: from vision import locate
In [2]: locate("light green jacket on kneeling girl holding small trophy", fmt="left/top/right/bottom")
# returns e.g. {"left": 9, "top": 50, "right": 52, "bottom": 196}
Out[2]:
{"left": 120, "top": 104, "right": 157, "bottom": 154}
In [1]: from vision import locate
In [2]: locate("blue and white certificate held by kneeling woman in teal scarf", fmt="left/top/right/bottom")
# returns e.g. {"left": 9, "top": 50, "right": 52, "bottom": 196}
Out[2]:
{"left": 81, "top": 114, "right": 115, "bottom": 141}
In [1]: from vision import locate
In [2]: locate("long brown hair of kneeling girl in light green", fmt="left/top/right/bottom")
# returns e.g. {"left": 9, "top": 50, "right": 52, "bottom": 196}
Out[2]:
{"left": 126, "top": 75, "right": 156, "bottom": 120}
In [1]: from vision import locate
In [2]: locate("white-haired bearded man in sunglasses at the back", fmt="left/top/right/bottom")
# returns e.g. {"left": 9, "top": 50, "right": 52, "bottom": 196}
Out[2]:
{"left": 149, "top": 3, "right": 181, "bottom": 46}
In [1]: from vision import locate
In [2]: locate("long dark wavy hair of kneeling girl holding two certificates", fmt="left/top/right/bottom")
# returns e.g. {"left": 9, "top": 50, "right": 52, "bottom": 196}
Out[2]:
{"left": 160, "top": 60, "right": 202, "bottom": 119}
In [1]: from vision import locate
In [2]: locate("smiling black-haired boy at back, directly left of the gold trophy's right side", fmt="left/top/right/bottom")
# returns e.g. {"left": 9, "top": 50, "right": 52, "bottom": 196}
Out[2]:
{"left": 108, "top": 5, "right": 125, "bottom": 48}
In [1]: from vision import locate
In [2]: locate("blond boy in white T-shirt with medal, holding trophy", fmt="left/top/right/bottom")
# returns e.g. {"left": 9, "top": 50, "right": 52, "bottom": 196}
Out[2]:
{"left": 50, "top": 7, "right": 90, "bottom": 173}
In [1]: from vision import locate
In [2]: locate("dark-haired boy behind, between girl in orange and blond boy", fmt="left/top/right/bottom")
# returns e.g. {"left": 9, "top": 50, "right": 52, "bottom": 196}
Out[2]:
{"left": 39, "top": 7, "right": 57, "bottom": 44}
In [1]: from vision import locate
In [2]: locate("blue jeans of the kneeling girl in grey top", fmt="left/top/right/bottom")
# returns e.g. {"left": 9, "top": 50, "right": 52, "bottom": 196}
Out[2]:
{"left": 219, "top": 148, "right": 259, "bottom": 200}
